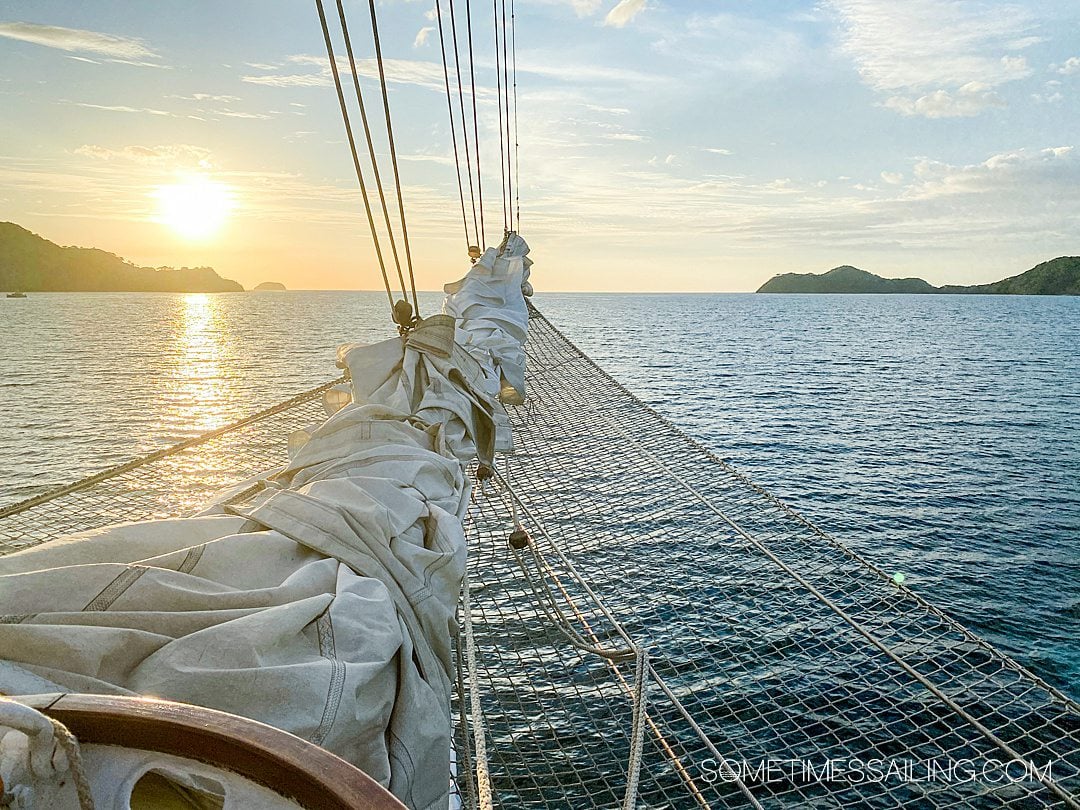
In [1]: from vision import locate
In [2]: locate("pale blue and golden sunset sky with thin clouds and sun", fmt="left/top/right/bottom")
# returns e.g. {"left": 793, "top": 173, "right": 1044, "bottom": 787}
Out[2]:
{"left": 0, "top": 0, "right": 1080, "bottom": 292}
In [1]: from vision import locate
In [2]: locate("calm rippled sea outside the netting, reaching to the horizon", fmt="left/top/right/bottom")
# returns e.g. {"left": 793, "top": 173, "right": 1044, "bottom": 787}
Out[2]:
{"left": 0, "top": 293, "right": 1080, "bottom": 697}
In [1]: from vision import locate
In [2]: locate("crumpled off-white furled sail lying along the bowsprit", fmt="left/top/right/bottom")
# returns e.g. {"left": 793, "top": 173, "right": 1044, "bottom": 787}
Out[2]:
{"left": 0, "top": 234, "right": 528, "bottom": 808}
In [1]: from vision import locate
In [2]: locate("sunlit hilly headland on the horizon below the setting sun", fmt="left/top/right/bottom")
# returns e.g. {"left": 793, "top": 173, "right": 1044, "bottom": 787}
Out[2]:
{"left": 0, "top": 222, "right": 244, "bottom": 293}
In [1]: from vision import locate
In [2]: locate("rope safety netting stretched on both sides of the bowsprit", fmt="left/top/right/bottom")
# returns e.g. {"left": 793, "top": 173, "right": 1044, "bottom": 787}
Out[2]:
{"left": 0, "top": 310, "right": 1080, "bottom": 808}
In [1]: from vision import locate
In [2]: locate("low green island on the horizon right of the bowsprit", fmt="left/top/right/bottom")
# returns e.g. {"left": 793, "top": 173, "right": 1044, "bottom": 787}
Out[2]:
{"left": 757, "top": 256, "right": 1080, "bottom": 295}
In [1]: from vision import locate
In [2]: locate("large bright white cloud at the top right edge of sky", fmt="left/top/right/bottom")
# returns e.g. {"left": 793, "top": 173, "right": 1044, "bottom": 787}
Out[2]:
{"left": 828, "top": 0, "right": 1040, "bottom": 118}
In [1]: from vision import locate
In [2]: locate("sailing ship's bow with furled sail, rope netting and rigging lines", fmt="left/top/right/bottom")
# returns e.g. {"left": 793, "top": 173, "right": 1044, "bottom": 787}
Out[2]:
{"left": 0, "top": 3, "right": 1080, "bottom": 810}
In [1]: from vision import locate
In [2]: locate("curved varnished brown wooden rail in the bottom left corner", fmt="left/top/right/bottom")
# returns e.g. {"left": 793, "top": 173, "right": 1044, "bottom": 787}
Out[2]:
{"left": 18, "top": 694, "right": 406, "bottom": 810}
